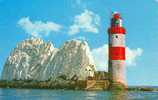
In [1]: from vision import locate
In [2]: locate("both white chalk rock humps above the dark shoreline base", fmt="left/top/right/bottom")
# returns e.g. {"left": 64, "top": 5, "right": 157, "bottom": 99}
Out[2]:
{"left": 2, "top": 38, "right": 95, "bottom": 81}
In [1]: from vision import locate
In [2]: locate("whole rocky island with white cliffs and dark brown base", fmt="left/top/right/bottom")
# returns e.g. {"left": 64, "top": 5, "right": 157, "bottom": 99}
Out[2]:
{"left": 0, "top": 38, "right": 109, "bottom": 90}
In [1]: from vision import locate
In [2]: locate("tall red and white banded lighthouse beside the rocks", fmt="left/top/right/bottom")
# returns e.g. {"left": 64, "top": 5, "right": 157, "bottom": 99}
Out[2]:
{"left": 108, "top": 12, "right": 126, "bottom": 87}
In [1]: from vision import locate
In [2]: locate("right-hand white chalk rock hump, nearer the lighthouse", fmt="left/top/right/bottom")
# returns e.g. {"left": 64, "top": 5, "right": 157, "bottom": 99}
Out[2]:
{"left": 52, "top": 40, "right": 95, "bottom": 80}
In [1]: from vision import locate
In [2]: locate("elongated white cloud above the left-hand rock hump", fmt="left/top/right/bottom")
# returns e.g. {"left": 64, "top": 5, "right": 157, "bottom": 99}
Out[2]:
{"left": 18, "top": 17, "right": 62, "bottom": 37}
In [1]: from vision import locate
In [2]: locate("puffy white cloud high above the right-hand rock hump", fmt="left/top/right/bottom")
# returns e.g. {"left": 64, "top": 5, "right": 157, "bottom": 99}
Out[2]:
{"left": 68, "top": 10, "right": 100, "bottom": 35}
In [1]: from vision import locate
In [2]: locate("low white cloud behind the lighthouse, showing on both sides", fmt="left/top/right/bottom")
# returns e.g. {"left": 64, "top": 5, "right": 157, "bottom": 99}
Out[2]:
{"left": 91, "top": 44, "right": 143, "bottom": 71}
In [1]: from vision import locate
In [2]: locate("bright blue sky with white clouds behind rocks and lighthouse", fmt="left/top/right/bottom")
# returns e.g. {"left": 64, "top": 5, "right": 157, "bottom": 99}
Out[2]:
{"left": 0, "top": 0, "right": 158, "bottom": 86}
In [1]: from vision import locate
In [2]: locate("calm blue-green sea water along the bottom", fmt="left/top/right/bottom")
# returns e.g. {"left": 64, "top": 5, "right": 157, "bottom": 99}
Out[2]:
{"left": 0, "top": 88, "right": 158, "bottom": 100}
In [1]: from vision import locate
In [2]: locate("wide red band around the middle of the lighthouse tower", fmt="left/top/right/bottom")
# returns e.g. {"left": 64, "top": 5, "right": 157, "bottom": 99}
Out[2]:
{"left": 109, "top": 47, "right": 126, "bottom": 60}
